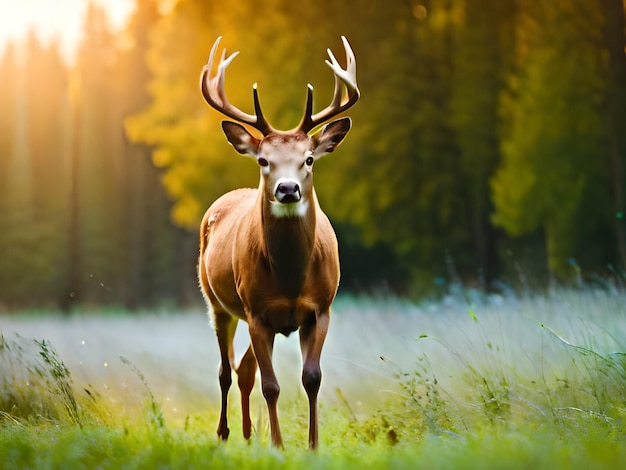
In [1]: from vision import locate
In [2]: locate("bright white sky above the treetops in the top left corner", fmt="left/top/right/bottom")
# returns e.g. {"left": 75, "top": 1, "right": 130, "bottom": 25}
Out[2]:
{"left": 0, "top": 0, "right": 135, "bottom": 60}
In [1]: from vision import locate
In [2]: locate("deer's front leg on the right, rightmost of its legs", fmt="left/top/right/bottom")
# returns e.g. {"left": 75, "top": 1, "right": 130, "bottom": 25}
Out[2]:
{"left": 300, "top": 312, "right": 330, "bottom": 449}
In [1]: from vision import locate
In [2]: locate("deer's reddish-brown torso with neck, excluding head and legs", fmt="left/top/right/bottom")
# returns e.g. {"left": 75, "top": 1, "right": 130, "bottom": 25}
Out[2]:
{"left": 200, "top": 185, "right": 339, "bottom": 335}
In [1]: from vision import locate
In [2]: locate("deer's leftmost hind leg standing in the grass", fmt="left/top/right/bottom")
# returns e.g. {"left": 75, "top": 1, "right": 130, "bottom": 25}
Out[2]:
{"left": 213, "top": 304, "right": 238, "bottom": 441}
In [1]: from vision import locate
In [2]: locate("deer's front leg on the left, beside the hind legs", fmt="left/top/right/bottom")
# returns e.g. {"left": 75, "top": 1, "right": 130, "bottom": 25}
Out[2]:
{"left": 249, "top": 321, "right": 283, "bottom": 447}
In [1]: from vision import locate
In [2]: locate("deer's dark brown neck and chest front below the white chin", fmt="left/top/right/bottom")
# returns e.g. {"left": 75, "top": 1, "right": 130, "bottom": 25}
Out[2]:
{"left": 261, "top": 188, "right": 317, "bottom": 298}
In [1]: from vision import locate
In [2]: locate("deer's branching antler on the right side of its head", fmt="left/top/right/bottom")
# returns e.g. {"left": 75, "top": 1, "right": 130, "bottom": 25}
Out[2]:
{"left": 297, "top": 36, "right": 360, "bottom": 133}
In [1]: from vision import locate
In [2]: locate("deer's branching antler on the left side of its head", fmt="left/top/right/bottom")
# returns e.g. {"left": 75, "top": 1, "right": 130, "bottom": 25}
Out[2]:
{"left": 200, "top": 36, "right": 273, "bottom": 136}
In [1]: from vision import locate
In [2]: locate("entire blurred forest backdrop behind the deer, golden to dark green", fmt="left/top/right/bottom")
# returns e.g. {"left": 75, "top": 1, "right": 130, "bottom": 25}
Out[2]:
{"left": 0, "top": 0, "right": 626, "bottom": 308}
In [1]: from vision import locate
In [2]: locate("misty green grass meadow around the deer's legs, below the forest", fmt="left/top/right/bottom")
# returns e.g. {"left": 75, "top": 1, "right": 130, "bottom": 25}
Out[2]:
{"left": 0, "top": 289, "right": 626, "bottom": 469}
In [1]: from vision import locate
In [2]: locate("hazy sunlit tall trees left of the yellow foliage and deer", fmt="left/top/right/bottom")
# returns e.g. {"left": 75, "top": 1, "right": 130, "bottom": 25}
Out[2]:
{"left": 0, "top": 1, "right": 196, "bottom": 309}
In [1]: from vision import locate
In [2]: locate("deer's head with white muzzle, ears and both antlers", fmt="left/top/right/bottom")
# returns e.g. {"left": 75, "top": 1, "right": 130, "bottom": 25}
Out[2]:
{"left": 200, "top": 36, "right": 359, "bottom": 217}
